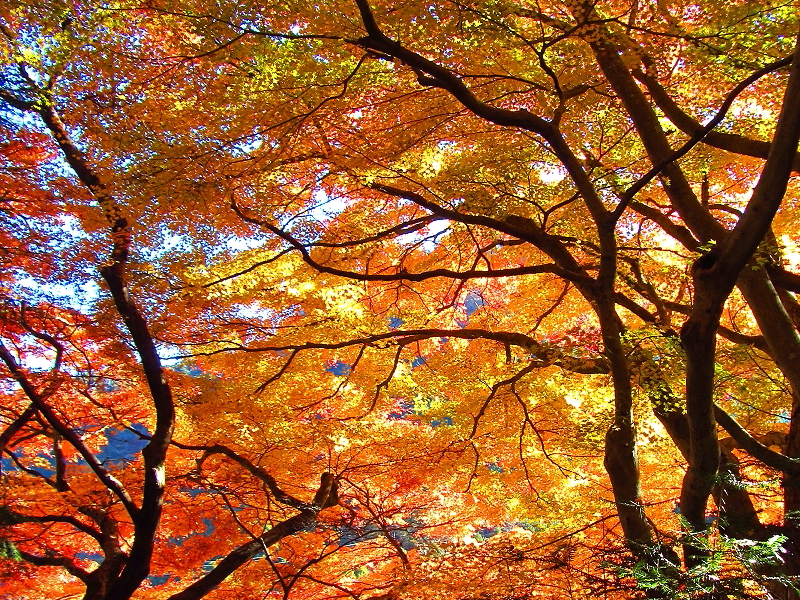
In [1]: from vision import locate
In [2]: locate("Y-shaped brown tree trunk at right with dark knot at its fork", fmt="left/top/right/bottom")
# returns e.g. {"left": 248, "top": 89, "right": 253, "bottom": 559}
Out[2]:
{"left": 591, "top": 10, "right": 800, "bottom": 564}
